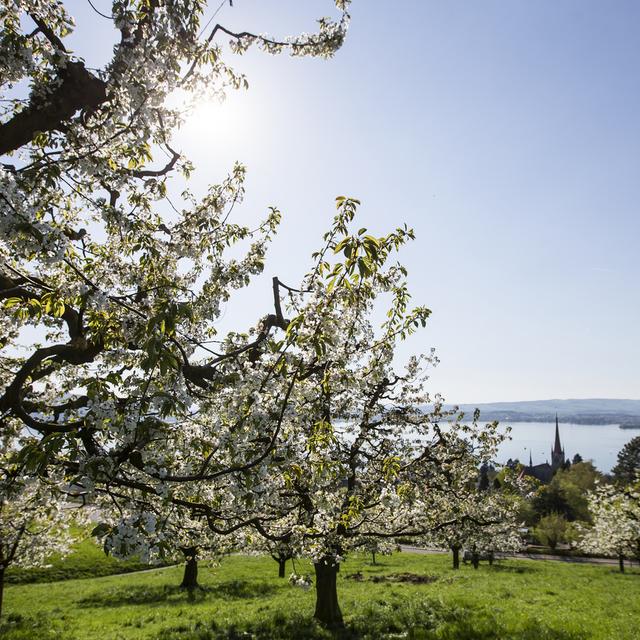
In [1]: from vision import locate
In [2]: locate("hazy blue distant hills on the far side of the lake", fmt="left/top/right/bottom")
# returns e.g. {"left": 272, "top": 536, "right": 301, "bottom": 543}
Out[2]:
{"left": 442, "top": 398, "right": 640, "bottom": 425}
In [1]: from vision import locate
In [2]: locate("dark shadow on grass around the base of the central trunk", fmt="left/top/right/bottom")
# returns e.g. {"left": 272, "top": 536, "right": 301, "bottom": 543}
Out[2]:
{"left": 162, "top": 600, "right": 588, "bottom": 640}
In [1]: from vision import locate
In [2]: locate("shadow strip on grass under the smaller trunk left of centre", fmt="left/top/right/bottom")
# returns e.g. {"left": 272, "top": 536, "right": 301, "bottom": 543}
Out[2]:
{"left": 77, "top": 580, "right": 278, "bottom": 608}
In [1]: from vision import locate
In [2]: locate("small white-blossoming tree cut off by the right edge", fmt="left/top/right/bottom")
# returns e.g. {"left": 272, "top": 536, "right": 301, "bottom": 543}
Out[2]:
{"left": 579, "top": 484, "right": 640, "bottom": 572}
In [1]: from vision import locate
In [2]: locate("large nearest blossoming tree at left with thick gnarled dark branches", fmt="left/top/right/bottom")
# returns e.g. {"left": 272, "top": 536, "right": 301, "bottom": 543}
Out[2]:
{"left": 0, "top": 0, "right": 349, "bottom": 534}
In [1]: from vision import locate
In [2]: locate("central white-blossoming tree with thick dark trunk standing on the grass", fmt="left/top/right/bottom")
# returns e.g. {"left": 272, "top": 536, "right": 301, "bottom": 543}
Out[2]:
{"left": 220, "top": 208, "right": 510, "bottom": 627}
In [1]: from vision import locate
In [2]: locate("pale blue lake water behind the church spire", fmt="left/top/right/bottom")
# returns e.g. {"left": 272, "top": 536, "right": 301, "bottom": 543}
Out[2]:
{"left": 498, "top": 421, "right": 640, "bottom": 473}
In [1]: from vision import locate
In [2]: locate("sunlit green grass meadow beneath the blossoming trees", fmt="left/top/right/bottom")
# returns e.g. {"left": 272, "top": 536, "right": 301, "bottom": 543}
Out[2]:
{"left": 0, "top": 553, "right": 640, "bottom": 640}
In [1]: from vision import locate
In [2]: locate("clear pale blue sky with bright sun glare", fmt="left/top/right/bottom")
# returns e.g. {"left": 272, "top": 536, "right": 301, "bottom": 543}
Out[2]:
{"left": 68, "top": 0, "right": 640, "bottom": 403}
